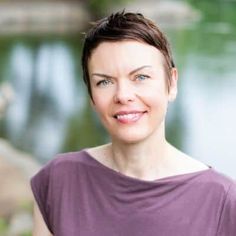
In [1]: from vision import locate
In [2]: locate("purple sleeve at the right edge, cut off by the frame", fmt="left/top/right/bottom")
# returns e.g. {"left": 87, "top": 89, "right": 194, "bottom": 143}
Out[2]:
{"left": 217, "top": 183, "right": 236, "bottom": 236}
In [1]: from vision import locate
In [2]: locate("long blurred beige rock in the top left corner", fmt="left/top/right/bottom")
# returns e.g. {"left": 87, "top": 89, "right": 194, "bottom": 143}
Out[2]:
{"left": 0, "top": 0, "right": 90, "bottom": 35}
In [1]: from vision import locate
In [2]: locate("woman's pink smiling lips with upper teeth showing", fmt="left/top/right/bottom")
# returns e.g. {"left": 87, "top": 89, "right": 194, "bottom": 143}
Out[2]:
{"left": 114, "top": 111, "right": 145, "bottom": 124}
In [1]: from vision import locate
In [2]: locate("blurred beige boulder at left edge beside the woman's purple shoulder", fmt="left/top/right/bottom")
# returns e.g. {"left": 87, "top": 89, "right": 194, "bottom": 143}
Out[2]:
{"left": 0, "top": 139, "right": 40, "bottom": 219}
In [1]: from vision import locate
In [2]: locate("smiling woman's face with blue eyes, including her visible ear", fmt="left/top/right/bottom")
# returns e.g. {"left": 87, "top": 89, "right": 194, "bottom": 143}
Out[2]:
{"left": 88, "top": 40, "right": 177, "bottom": 143}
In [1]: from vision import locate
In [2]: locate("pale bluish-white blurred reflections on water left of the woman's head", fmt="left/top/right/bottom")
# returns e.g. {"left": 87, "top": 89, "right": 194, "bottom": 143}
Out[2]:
{"left": 5, "top": 42, "right": 90, "bottom": 162}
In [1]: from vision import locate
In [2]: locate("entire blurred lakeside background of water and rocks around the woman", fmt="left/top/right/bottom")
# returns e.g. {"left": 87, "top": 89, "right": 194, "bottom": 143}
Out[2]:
{"left": 0, "top": 0, "right": 236, "bottom": 236}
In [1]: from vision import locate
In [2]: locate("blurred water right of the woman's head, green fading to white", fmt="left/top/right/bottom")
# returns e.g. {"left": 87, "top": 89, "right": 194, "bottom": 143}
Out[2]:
{"left": 167, "top": 5, "right": 236, "bottom": 178}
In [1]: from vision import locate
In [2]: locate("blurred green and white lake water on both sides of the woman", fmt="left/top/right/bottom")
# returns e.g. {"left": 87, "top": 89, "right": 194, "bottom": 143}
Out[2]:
{"left": 0, "top": 1, "right": 236, "bottom": 178}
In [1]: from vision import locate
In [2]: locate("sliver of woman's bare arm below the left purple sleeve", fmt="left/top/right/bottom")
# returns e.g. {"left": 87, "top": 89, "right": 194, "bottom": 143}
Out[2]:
{"left": 33, "top": 199, "right": 53, "bottom": 236}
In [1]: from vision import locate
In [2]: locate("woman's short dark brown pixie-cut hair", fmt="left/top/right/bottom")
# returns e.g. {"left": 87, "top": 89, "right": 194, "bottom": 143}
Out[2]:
{"left": 82, "top": 11, "right": 175, "bottom": 98}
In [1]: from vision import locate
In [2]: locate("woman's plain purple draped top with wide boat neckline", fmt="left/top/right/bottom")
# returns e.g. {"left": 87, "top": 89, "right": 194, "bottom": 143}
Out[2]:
{"left": 31, "top": 150, "right": 236, "bottom": 236}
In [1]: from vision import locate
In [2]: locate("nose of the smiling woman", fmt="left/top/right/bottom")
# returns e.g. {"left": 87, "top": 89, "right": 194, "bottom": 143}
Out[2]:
{"left": 114, "top": 83, "right": 135, "bottom": 104}
